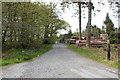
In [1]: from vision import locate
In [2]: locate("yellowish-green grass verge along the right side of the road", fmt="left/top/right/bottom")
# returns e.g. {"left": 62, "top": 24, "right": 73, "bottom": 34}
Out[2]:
{"left": 67, "top": 44, "right": 120, "bottom": 69}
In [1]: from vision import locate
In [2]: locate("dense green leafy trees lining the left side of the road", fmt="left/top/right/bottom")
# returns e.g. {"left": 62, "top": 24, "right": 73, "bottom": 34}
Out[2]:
{"left": 2, "top": 2, "right": 69, "bottom": 50}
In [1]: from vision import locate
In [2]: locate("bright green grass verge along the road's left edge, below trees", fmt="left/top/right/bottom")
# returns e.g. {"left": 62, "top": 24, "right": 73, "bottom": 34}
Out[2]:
{"left": 0, "top": 45, "right": 52, "bottom": 66}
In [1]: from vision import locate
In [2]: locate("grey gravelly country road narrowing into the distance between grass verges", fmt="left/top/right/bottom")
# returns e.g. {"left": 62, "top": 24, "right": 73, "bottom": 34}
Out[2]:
{"left": 2, "top": 44, "right": 118, "bottom": 78}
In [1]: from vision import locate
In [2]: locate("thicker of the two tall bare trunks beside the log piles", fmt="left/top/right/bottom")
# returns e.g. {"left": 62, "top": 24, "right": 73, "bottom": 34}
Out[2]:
{"left": 86, "top": 0, "right": 92, "bottom": 47}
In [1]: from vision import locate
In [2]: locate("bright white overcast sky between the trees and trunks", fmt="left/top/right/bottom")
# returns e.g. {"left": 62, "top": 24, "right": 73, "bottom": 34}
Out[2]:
{"left": 31, "top": 0, "right": 118, "bottom": 33}
